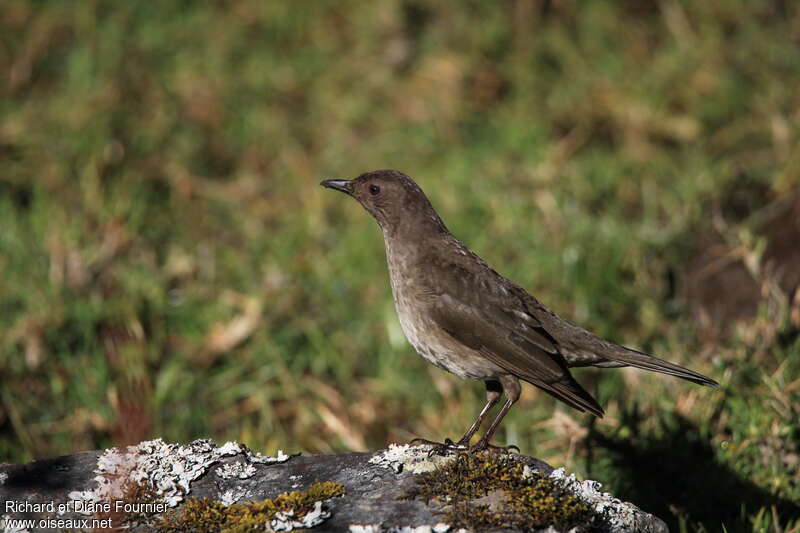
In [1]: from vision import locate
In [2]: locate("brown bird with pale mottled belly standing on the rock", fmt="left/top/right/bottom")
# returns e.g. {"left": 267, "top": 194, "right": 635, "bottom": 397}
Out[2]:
{"left": 320, "top": 170, "right": 717, "bottom": 451}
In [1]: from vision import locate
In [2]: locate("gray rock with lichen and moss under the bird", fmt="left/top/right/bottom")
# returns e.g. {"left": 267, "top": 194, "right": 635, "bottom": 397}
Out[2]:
{"left": 0, "top": 439, "right": 667, "bottom": 533}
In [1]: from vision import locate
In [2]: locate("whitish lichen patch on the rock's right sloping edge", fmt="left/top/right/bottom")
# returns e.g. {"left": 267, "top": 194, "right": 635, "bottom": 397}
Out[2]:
{"left": 550, "top": 468, "right": 643, "bottom": 533}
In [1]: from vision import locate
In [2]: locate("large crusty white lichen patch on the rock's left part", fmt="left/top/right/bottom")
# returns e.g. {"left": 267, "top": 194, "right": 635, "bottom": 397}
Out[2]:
{"left": 69, "top": 439, "right": 289, "bottom": 514}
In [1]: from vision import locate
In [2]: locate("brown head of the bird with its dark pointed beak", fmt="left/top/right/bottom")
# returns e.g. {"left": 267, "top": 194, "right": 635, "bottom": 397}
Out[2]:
{"left": 320, "top": 170, "right": 444, "bottom": 233}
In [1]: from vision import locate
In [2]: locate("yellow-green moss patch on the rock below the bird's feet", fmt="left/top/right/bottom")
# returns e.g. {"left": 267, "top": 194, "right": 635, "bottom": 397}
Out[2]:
{"left": 406, "top": 454, "right": 591, "bottom": 531}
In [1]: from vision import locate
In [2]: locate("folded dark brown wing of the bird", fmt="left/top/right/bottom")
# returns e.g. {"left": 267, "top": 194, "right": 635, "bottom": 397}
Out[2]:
{"left": 423, "top": 254, "right": 603, "bottom": 416}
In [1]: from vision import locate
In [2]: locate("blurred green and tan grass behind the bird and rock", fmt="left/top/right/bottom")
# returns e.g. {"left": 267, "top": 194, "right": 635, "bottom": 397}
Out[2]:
{"left": 0, "top": 0, "right": 800, "bottom": 531}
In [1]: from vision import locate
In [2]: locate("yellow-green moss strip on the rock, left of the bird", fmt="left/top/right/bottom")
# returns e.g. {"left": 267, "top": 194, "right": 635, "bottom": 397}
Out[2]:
{"left": 154, "top": 481, "right": 344, "bottom": 533}
